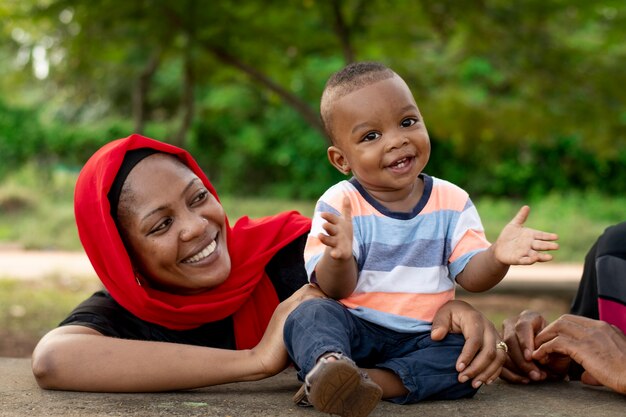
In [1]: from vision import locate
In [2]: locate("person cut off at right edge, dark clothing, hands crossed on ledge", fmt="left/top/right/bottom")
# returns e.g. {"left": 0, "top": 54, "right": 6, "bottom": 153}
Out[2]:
{"left": 502, "top": 222, "right": 626, "bottom": 394}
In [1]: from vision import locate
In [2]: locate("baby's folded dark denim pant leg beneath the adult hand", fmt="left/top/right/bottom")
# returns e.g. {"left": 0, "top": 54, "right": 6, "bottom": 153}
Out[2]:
{"left": 379, "top": 333, "right": 478, "bottom": 404}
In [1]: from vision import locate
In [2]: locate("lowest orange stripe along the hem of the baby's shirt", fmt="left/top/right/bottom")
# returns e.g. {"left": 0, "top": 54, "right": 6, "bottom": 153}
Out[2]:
{"left": 341, "top": 289, "right": 454, "bottom": 321}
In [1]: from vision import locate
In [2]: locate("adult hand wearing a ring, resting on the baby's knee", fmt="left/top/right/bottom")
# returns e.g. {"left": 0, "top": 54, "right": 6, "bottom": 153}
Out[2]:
{"left": 431, "top": 300, "right": 507, "bottom": 388}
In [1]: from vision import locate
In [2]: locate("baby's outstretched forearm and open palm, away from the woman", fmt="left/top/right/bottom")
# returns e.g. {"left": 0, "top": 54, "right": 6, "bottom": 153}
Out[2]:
{"left": 456, "top": 206, "right": 559, "bottom": 292}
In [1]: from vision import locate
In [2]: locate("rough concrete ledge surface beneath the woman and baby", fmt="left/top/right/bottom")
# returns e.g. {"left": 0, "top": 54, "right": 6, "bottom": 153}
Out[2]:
{"left": 0, "top": 358, "right": 626, "bottom": 417}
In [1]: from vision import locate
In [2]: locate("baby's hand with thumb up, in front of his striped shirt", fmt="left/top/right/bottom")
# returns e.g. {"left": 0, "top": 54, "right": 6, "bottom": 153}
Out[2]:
{"left": 318, "top": 197, "right": 353, "bottom": 259}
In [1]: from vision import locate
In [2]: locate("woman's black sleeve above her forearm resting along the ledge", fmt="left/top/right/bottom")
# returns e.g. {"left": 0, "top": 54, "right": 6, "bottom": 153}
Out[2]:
{"left": 60, "top": 291, "right": 235, "bottom": 349}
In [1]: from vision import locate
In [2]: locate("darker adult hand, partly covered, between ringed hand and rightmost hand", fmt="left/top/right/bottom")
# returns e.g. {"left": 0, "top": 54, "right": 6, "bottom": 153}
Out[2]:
{"left": 500, "top": 310, "right": 547, "bottom": 384}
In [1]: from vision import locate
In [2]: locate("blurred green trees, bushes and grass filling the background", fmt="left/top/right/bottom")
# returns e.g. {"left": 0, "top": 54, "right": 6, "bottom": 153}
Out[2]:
{"left": 0, "top": 0, "right": 626, "bottom": 352}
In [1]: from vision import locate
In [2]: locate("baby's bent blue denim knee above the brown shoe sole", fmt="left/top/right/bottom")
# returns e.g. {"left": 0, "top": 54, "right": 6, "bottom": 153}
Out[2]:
{"left": 283, "top": 298, "right": 354, "bottom": 380}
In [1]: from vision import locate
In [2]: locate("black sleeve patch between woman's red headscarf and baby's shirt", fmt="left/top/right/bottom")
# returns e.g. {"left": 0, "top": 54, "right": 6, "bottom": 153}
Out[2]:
{"left": 265, "top": 233, "right": 309, "bottom": 301}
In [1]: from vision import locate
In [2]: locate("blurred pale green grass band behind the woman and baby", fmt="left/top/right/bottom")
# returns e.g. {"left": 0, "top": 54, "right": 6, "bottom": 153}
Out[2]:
{"left": 0, "top": 164, "right": 626, "bottom": 262}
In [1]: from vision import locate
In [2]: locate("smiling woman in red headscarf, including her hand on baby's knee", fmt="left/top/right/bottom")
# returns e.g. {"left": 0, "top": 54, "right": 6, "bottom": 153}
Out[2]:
{"left": 32, "top": 135, "right": 498, "bottom": 392}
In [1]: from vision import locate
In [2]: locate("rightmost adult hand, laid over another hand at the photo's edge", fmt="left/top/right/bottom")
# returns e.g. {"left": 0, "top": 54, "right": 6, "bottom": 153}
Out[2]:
{"left": 532, "top": 314, "right": 626, "bottom": 394}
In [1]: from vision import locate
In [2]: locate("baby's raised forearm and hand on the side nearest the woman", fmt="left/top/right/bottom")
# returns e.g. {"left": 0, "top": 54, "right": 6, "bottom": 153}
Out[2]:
{"left": 315, "top": 197, "right": 357, "bottom": 299}
